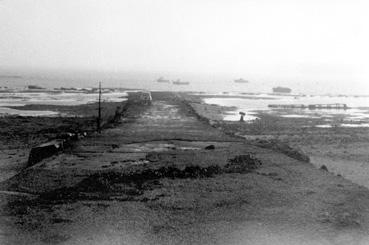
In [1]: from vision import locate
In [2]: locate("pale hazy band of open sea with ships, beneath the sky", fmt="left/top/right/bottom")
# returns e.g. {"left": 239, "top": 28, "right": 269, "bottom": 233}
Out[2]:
{"left": 0, "top": 70, "right": 369, "bottom": 95}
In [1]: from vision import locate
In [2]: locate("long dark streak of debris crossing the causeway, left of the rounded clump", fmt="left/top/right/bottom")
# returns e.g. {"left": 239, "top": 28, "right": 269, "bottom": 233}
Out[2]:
{"left": 36, "top": 165, "right": 222, "bottom": 201}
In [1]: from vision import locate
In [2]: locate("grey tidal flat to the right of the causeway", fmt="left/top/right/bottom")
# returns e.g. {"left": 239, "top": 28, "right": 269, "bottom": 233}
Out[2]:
{"left": 190, "top": 96, "right": 369, "bottom": 188}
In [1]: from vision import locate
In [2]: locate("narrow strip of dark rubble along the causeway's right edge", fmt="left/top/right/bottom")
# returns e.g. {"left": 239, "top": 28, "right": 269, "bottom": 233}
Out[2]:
{"left": 256, "top": 139, "right": 310, "bottom": 162}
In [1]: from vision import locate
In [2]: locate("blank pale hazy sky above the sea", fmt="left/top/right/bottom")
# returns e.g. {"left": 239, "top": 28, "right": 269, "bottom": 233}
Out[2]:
{"left": 0, "top": 0, "right": 369, "bottom": 93}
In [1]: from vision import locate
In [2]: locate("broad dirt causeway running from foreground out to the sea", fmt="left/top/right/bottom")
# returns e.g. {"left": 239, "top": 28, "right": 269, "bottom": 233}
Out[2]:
{"left": 0, "top": 93, "right": 369, "bottom": 244}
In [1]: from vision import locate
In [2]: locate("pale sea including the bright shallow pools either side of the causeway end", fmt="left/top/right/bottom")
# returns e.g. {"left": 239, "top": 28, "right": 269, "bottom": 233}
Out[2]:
{"left": 0, "top": 71, "right": 369, "bottom": 121}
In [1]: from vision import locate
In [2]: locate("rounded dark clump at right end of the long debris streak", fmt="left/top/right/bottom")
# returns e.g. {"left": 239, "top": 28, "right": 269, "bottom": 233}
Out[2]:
{"left": 223, "top": 154, "right": 262, "bottom": 173}
